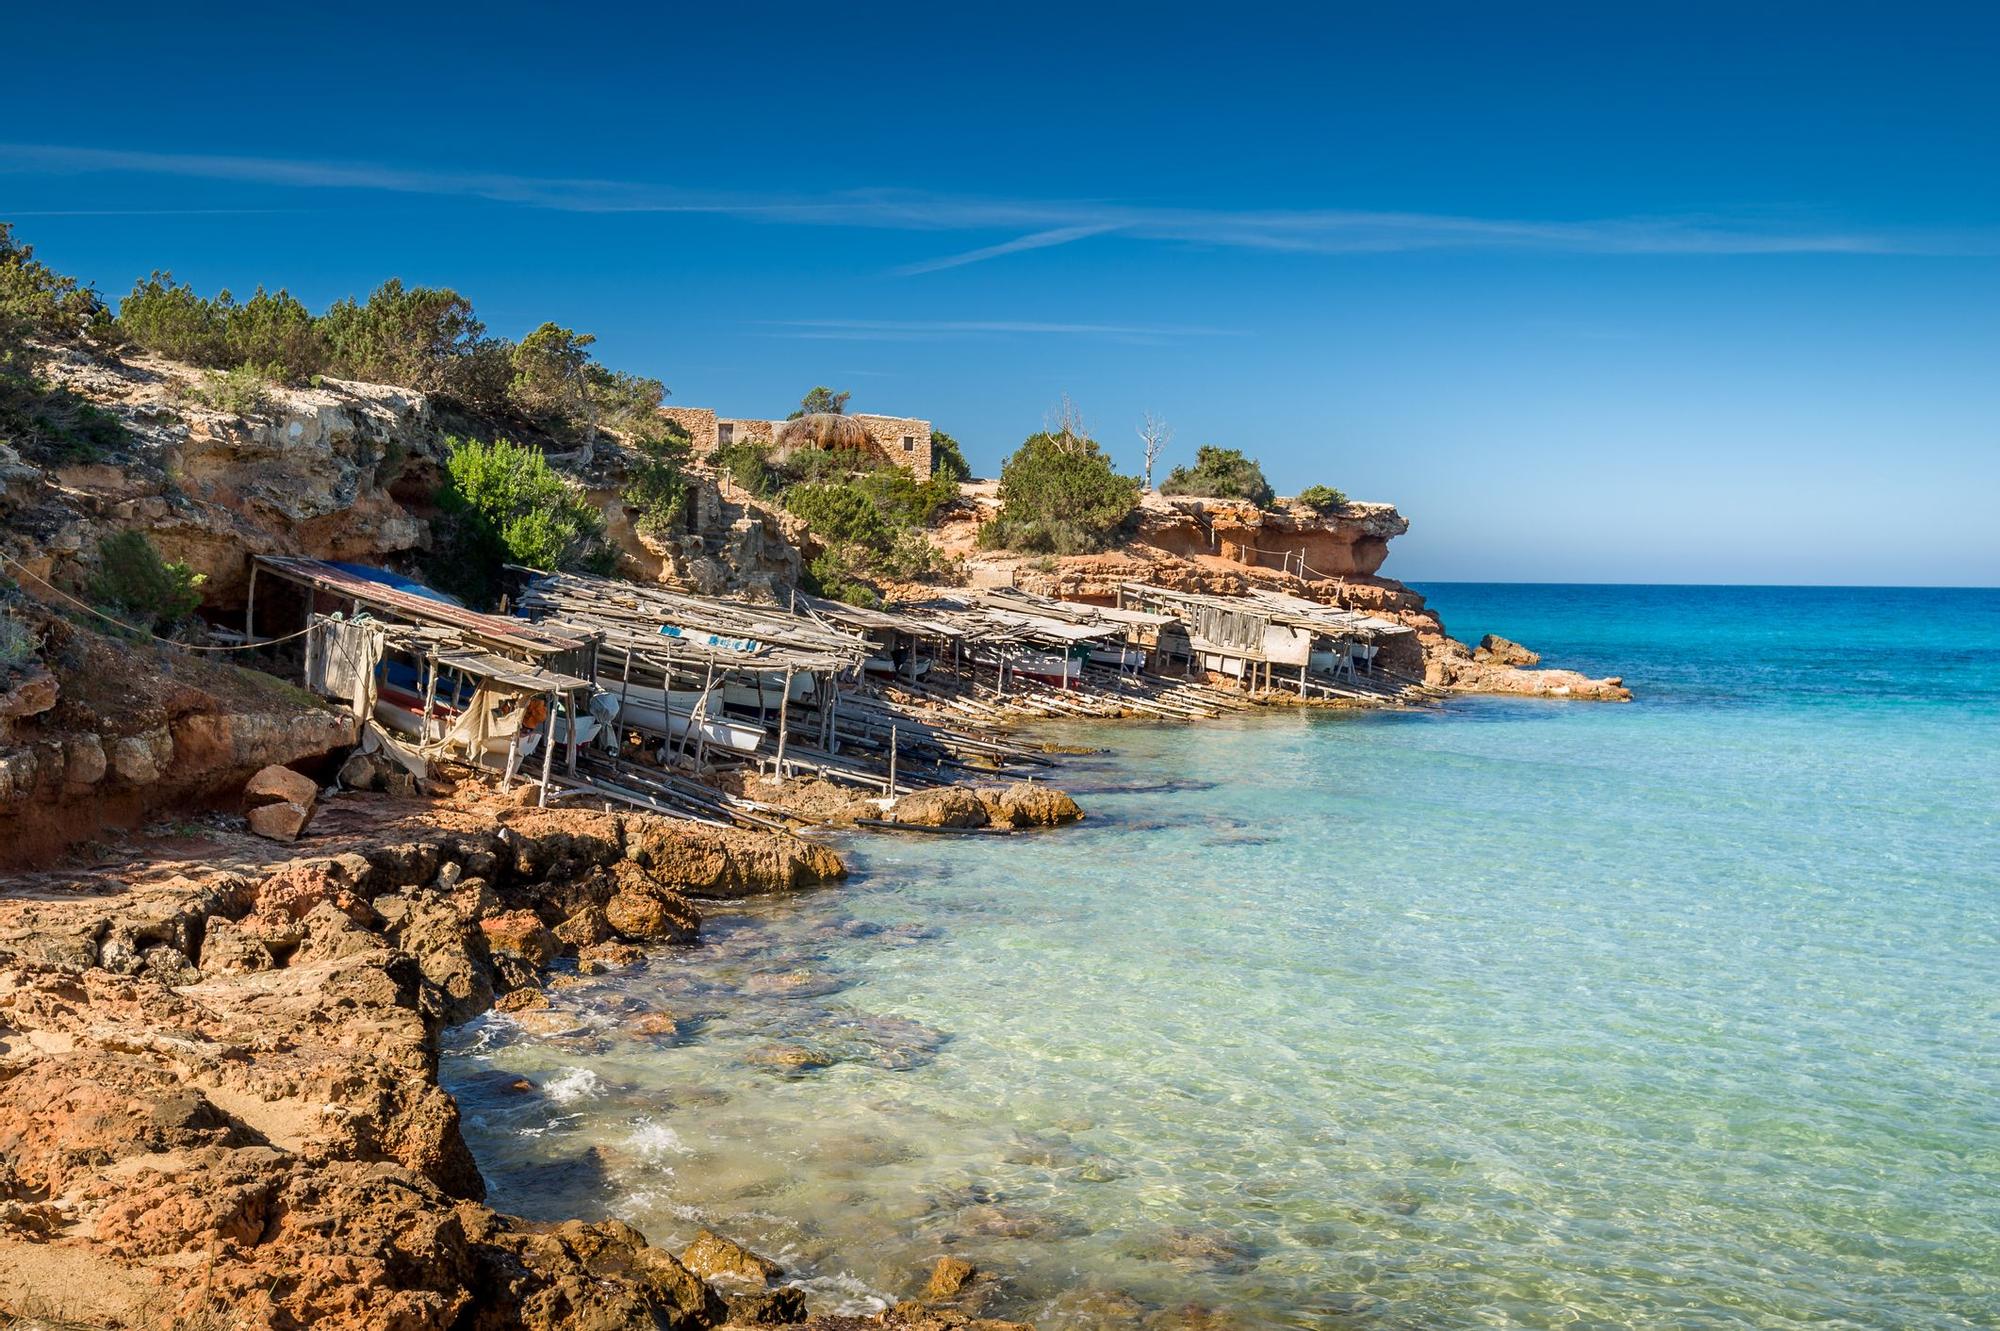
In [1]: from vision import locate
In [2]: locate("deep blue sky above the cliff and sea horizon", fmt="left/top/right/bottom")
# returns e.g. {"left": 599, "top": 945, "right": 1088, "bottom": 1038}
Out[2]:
{"left": 0, "top": 4, "right": 2000, "bottom": 586}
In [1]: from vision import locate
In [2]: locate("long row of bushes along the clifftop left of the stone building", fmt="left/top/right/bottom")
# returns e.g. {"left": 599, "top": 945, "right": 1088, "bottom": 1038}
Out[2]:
{"left": 114, "top": 272, "right": 666, "bottom": 444}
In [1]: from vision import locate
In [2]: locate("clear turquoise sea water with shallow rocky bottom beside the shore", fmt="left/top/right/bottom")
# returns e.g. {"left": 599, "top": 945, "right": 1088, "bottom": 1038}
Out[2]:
{"left": 446, "top": 586, "right": 2000, "bottom": 1329}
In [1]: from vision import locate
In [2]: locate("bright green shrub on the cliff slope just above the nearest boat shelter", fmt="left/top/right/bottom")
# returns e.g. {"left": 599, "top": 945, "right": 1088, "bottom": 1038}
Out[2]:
{"left": 434, "top": 438, "right": 616, "bottom": 604}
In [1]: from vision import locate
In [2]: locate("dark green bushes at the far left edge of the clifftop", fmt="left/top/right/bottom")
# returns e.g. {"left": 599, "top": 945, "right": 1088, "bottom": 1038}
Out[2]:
{"left": 0, "top": 222, "right": 126, "bottom": 464}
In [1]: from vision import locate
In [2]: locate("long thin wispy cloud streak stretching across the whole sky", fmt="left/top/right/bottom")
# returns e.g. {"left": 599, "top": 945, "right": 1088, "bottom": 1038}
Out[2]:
{"left": 0, "top": 144, "right": 1976, "bottom": 263}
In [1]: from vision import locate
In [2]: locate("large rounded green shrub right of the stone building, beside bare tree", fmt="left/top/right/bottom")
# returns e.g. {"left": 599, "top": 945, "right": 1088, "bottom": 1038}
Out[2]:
{"left": 980, "top": 432, "right": 1138, "bottom": 554}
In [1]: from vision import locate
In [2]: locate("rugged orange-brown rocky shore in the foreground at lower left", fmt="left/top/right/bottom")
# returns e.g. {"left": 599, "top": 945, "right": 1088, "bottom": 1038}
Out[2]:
{"left": 0, "top": 791, "right": 838, "bottom": 1331}
